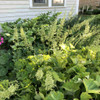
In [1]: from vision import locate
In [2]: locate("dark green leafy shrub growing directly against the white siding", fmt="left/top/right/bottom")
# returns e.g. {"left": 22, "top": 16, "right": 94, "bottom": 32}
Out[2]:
{"left": 1, "top": 12, "right": 60, "bottom": 46}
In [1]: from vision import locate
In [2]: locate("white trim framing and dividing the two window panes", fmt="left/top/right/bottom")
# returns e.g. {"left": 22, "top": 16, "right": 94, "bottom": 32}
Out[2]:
{"left": 29, "top": 0, "right": 66, "bottom": 8}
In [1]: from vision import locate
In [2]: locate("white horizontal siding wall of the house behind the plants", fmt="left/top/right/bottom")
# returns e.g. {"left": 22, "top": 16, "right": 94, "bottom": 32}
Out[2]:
{"left": 0, "top": 0, "right": 79, "bottom": 31}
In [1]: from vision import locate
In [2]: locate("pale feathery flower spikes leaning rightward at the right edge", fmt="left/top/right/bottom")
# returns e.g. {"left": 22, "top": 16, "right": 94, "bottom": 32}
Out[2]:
{"left": 65, "top": 15, "right": 100, "bottom": 51}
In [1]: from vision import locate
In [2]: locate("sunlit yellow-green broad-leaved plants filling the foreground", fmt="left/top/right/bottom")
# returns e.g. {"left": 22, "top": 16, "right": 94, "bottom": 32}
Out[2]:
{"left": 11, "top": 44, "right": 100, "bottom": 100}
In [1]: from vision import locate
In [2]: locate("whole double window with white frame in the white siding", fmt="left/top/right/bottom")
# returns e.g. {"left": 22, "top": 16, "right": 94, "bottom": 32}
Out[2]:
{"left": 30, "top": 0, "right": 66, "bottom": 8}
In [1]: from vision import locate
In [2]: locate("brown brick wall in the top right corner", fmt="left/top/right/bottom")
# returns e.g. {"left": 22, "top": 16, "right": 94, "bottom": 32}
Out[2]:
{"left": 79, "top": 0, "right": 100, "bottom": 8}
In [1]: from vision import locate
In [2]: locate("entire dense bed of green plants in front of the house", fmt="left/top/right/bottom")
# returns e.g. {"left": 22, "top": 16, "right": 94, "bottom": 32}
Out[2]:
{"left": 0, "top": 12, "right": 100, "bottom": 100}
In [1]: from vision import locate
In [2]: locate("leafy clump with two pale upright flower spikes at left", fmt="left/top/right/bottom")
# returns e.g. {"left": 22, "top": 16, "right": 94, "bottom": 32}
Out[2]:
{"left": 9, "top": 27, "right": 34, "bottom": 61}
